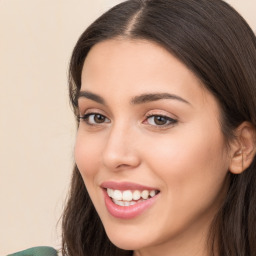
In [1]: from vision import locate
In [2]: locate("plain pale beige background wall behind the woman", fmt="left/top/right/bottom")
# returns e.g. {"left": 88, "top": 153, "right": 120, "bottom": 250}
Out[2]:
{"left": 0, "top": 0, "right": 256, "bottom": 255}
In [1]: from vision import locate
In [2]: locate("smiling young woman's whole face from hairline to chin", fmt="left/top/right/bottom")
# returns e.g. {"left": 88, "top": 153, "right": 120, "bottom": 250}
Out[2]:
{"left": 75, "top": 39, "right": 230, "bottom": 255}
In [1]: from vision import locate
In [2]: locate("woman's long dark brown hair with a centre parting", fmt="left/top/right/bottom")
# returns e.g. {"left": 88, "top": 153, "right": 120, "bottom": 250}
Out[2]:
{"left": 63, "top": 0, "right": 256, "bottom": 256}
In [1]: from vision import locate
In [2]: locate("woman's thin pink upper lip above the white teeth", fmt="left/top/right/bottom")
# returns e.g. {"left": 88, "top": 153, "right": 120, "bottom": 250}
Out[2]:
{"left": 101, "top": 181, "right": 159, "bottom": 191}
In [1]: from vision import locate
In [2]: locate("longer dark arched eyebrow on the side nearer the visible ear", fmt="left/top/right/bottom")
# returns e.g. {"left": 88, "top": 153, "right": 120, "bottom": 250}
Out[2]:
{"left": 131, "top": 93, "right": 191, "bottom": 105}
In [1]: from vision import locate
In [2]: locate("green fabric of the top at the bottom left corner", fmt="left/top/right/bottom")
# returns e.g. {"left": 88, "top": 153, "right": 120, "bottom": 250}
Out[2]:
{"left": 7, "top": 246, "right": 58, "bottom": 256}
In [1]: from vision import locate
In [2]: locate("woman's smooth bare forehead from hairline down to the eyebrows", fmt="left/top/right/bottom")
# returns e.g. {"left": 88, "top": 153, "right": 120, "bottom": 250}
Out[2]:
{"left": 81, "top": 38, "right": 215, "bottom": 109}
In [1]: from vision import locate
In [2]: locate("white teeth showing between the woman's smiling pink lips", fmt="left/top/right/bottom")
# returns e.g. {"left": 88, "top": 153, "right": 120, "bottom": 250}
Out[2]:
{"left": 106, "top": 188, "right": 160, "bottom": 207}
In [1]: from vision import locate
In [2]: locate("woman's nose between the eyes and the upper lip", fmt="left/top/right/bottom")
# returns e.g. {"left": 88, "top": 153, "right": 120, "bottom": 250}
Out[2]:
{"left": 102, "top": 124, "right": 140, "bottom": 171}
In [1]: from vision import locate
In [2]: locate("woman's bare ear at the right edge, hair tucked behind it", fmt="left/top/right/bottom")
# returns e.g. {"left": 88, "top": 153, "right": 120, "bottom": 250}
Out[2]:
{"left": 229, "top": 122, "right": 256, "bottom": 174}
